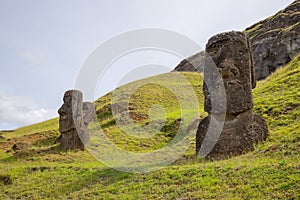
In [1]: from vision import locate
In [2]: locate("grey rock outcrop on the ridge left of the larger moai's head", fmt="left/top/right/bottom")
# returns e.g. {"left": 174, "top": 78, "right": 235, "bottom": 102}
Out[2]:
{"left": 173, "top": 51, "right": 205, "bottom": 72}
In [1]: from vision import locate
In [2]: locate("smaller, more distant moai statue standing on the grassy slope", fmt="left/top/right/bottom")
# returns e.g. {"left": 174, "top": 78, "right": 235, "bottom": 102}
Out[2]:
{"left": 58, "top": 90, "right": 95, "bottom": 150}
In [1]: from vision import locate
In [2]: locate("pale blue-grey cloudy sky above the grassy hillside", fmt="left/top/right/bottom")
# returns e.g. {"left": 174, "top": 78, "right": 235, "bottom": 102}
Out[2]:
{"left": 0, "top": 0, "right": 292, "bottom": 130}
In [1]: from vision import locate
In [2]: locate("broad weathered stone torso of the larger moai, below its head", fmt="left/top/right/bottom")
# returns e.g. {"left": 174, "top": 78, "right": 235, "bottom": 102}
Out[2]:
{"left": 196, "top": 110, "right": 268, "bottom": 159}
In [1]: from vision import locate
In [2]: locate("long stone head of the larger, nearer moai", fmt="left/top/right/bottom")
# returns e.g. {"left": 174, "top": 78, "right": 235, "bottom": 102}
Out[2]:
{"left": 203, "top": 31, "right": 256, "bottom": 114}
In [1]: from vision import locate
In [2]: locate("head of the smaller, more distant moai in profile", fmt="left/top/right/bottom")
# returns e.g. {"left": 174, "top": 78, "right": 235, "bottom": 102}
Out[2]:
{"left": 58, "top": 90, "right": 82, "bottom": 133}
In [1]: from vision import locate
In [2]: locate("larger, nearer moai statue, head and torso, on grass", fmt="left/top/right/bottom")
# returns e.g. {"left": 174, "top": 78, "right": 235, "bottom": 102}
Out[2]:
{"left": 196, "top": 31, "right": 268, "bottom": 159}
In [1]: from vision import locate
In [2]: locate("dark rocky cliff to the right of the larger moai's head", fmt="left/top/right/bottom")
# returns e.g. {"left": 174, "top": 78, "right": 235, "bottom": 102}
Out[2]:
{"left": 245, "top": 0, "right": 300, "bottom": 80}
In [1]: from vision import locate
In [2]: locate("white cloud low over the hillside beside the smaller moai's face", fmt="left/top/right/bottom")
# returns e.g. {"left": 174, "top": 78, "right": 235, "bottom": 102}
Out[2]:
{"left": 0, "top": 93, "right": 57, "bottom": 130}
